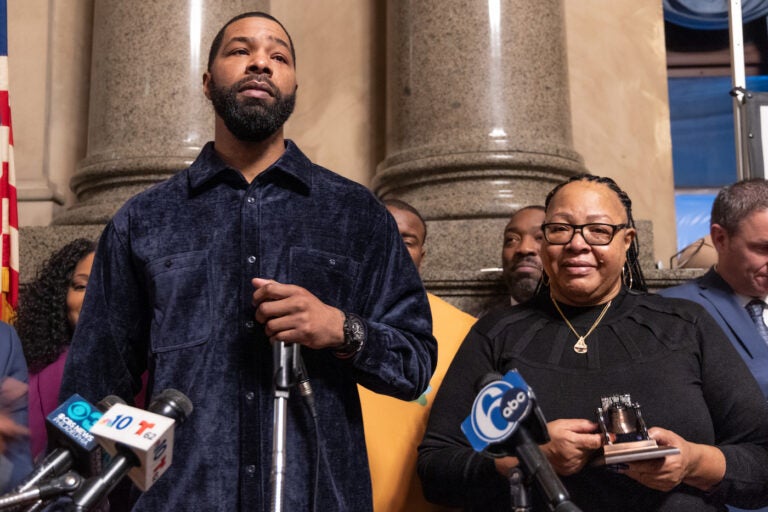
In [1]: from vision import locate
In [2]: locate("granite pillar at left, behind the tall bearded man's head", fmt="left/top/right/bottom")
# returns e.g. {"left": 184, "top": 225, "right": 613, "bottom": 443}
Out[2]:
{"left": 54, "top": 0, "right": 269, "bottom": 224}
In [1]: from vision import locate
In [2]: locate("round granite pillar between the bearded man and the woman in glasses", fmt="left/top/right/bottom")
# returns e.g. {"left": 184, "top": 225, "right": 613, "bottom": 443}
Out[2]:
{"left": 374, "top": 0, "right": 584, "bottom": 314}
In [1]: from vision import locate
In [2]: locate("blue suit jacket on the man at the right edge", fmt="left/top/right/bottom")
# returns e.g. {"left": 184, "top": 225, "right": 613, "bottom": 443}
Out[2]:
{"left": 659, "top": 268, "right": 768, "bottom": 398}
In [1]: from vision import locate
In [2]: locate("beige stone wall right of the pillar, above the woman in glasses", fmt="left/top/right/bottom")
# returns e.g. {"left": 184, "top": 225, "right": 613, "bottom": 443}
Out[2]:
{"left": 563, "top": 0, "right": 676, "bottom": 262}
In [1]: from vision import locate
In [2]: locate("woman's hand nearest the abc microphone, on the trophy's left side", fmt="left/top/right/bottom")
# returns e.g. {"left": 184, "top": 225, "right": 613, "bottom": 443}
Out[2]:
{"left": 541, "top": 419, "right": 603, "bottom": 476}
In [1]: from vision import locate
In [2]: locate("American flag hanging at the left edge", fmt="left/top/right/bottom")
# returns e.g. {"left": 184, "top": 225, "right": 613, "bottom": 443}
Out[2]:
{"left": 0, "top": 0, "right": 19, "bottom": 322}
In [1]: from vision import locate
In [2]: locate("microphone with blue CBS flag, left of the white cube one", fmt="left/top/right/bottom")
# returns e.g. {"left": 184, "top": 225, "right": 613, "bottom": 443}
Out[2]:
{"left": 16, "top": 393, "right": 125, "bottom": 492}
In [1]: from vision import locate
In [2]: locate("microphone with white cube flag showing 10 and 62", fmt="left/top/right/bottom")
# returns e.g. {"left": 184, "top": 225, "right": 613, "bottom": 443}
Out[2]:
{"left": 70, "top": 389, "right": 193, "bottom": 511}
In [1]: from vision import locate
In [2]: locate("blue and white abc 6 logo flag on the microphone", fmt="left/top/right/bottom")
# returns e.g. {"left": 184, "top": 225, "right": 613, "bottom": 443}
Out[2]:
{"left": 461, "top": 370, "right": 534, "bottom": 456}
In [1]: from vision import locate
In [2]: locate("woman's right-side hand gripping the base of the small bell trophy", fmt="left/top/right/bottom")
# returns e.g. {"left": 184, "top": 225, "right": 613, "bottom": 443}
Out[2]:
{"left": 620, "top": 427, "right": 725, "bottom": 491}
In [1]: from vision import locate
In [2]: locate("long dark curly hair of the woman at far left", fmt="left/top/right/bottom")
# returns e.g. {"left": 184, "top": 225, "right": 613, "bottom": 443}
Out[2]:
{"left": 15, "top": 238, "right": 96, "bottom": 373}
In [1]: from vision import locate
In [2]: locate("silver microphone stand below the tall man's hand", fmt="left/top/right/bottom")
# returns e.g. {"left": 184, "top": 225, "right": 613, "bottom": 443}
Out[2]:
{"left": 270, "top": 341, "right": 301, "bottom": 512}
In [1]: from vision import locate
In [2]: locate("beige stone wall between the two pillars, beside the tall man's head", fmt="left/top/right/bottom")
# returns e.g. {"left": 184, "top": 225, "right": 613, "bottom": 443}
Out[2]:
{"left": 271, "top": 0, "right": 386, "bottom": 186}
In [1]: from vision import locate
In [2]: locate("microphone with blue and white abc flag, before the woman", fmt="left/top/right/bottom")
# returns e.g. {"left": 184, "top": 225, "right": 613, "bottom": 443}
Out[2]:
{"left": 461, "top": 370, "right": 580, "bottom": 512}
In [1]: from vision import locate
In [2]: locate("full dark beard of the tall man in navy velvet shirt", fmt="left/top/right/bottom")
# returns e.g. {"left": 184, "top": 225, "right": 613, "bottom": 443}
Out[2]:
{"left": 208, "top": 76, "right": 296, "bottom": 142}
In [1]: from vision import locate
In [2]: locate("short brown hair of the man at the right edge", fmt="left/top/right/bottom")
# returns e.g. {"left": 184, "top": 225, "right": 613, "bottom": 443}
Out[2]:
{"left": 709, "top": 178, "right": 768, "bottom": 235}
